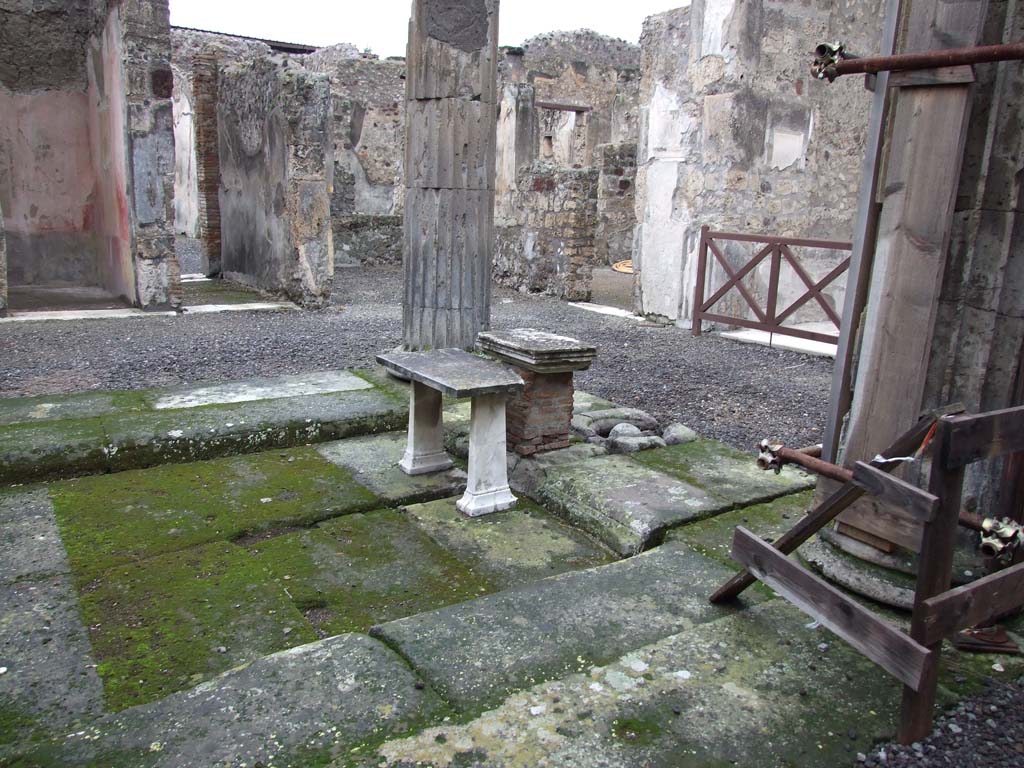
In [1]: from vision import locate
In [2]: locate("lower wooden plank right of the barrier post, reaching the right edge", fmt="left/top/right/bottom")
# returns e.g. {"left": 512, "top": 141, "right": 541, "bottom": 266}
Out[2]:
{"left": 921, "top": 563, "right": 1024, "bottom": 645}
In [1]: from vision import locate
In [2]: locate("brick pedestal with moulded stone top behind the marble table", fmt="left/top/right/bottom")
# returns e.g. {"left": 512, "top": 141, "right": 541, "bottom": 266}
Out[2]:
{"left": 477, "top": 329, "right": 597, "bottom": 456}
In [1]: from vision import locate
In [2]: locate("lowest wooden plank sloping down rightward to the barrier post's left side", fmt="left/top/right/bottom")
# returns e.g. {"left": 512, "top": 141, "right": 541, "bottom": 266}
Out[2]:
{"left": 732, "top": 527, "right": 932, "bottom": 689}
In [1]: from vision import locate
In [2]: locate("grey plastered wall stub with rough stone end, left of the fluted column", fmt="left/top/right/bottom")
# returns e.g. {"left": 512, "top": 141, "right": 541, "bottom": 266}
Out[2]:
{"left": 218, "top": 57, "right": 334, "bottom": 307}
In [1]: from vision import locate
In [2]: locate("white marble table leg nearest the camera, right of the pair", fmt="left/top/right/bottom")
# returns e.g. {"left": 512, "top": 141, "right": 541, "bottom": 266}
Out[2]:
{"left": 456, "top": 393, "right": 516, "bottom": 517}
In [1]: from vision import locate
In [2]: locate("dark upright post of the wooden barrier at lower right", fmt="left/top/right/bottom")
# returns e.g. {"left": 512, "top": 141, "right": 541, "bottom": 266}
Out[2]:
{"left": 899, "top": 420, "right": 964, "bottom": 744}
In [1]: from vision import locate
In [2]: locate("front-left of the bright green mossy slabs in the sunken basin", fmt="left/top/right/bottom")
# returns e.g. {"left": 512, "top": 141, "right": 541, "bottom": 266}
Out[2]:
{"left": 80, "top": 542, "right": 316, "bottom": 711}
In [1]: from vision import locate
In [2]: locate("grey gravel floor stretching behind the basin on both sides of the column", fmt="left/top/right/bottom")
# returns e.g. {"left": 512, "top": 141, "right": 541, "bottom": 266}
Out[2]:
{"left": 0, "top": 267, "right": 831, "bottom": 450}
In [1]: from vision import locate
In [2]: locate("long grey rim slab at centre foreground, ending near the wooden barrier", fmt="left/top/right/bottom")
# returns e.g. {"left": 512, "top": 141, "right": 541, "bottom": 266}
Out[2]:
{"left": 371, "top": 545, "right": 759, "bottom": 712}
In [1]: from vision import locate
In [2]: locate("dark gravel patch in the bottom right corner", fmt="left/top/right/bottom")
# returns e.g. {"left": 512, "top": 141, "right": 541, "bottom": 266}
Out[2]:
{"left": 855, "top": 678, "right": 1024, "bottom": 768}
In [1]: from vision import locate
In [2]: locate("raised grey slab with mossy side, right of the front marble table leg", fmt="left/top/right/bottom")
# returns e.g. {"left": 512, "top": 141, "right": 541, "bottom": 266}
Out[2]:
{"left": 536, "top": 456, "right": 732, "bottom": 557}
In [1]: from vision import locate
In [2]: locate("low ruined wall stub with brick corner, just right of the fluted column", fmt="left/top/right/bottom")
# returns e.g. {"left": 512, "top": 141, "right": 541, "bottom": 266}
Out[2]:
{"left": 494, "top": 161, "right": 599, "bottom": 301}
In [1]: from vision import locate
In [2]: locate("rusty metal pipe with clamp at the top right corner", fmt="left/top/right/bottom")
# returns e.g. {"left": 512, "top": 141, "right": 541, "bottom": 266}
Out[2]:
{"left": 811, "top": 43, "right": 1024, "bottom": 82}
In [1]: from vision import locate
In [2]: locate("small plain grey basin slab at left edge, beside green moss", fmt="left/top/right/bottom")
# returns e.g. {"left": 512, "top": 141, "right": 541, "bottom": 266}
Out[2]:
{"left": 0, "top": 486, "right": 70, "bottom": 584}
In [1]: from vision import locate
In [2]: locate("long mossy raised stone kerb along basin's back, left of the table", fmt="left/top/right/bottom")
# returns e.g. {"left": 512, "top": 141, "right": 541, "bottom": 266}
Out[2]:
{"left": 0, "top": 373, "right": 409, "bottom": 485}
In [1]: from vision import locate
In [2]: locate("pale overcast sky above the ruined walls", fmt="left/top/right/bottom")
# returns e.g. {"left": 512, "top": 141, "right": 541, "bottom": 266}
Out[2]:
{"left": 170, "top": 0, "right": 689, "bottom": 56}
